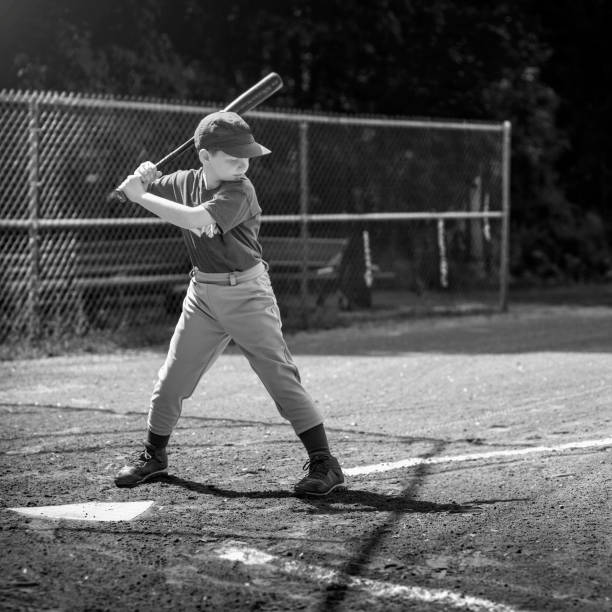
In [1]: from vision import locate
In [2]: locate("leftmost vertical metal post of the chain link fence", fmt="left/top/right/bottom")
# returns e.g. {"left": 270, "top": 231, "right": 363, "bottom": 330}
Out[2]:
{"left": 26, "top": 99, "right": 40, "bottom": 340}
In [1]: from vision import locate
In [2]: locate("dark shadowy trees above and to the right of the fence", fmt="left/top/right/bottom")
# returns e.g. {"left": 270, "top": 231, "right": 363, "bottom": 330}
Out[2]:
{"left": 0, "top": 0, "right": 612, "bottom": 282}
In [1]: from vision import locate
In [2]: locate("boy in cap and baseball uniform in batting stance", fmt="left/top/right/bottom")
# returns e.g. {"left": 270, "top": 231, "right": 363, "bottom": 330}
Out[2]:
{"left": 115, "top": 111, "right": 344, "bottom": 496}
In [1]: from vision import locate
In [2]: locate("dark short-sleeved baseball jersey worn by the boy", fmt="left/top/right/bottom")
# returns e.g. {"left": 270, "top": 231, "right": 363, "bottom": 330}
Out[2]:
{"left": 149, "top": 168, "right": 262, "bottom": 272}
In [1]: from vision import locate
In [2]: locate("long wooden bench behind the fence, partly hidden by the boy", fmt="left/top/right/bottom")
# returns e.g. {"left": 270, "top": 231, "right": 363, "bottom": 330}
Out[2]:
{"left": 3, "top": 232, "right": 382, "bottom": 321}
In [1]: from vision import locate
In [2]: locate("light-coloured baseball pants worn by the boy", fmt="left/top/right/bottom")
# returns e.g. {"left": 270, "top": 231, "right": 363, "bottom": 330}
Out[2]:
{"left": 148, "top": 264, "right": 323, "bottom": 435}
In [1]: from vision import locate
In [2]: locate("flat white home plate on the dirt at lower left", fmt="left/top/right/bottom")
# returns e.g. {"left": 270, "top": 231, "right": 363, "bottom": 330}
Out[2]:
{"left": 9, "top": 500, "right": 154, "bottom": 521}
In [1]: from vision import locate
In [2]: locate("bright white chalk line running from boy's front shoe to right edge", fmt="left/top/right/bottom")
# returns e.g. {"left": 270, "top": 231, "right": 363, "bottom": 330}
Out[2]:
{"left": 342, "top": 438, "right": 612, "bottom": 476}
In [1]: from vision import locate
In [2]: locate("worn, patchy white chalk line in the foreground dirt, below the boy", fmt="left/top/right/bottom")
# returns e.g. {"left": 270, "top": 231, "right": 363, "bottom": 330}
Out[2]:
{"left": 217, "top": 542, "right": 520, "bottom": 612}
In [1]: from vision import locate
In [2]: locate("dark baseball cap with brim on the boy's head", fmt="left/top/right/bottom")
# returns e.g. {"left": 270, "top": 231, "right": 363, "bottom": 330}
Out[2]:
{"left": 193, "top": 111, "right": 271, "bottom": 157}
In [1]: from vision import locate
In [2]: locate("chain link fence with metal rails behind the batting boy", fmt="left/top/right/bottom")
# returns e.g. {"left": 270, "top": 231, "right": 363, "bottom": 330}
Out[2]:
{"left": 0, "top": 91, "right": 510, "bottom": 342}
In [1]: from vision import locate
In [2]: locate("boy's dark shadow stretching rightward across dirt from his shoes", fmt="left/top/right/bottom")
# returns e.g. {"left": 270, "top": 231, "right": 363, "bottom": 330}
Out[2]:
{"left": 155, "top": 475, "right": 481, "bottom": 514}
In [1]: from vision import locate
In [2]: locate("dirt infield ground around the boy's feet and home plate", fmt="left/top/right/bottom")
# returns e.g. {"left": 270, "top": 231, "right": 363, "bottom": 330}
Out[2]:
{"left": 0, "top": 305, "right": 612, "bottom": 612}
